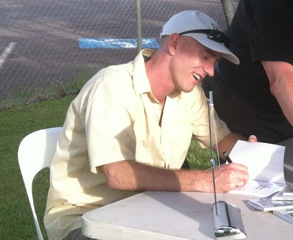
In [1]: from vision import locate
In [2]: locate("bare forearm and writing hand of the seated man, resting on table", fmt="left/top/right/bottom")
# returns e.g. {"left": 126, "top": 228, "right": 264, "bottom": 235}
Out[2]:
{"left": 103, "top": 160, "right": 248, "bottom": 192}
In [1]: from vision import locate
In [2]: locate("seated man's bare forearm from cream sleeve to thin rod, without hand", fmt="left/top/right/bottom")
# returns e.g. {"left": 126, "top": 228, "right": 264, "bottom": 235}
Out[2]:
{"left": 103, "top": 160, "right": 207, "bottom": 191}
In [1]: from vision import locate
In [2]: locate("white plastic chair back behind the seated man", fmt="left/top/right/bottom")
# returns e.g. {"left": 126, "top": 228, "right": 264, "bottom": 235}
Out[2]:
{"left": 18, "top": 127, "right": 62, "bottom": 240}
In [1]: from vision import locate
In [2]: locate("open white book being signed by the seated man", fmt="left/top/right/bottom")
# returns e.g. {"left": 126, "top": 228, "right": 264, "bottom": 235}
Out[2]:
{"left": 229, "top": 141, "right": 286, "bottom": 197}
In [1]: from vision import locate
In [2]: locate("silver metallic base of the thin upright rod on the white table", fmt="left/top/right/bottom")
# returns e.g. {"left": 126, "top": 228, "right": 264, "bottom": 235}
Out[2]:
{"left": 212, "top": 201, "right": 246, "bottom": 239}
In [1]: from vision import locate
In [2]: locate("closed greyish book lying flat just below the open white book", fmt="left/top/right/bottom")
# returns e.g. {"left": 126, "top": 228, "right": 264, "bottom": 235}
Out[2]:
{"left": 248, "top": 196, "right": 293, "bottom": 211}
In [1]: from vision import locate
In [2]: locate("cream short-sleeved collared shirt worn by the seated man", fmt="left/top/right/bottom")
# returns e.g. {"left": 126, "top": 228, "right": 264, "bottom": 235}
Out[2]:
{"left": 44, "top": 49, "right": 229, "bottom": 240}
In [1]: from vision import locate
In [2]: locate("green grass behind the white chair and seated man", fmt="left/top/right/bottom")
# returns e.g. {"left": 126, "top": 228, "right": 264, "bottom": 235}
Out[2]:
{"left": 0, "top": 96, "right": 210, "bottom": 240}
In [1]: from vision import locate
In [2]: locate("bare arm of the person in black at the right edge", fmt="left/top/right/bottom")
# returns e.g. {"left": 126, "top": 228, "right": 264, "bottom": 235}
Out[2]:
{"left": 262, "top": 61, "right": 293, "bottom": 126}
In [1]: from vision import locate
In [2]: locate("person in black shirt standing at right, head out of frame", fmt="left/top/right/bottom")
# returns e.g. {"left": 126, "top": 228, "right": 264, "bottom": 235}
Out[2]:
{"left": 203, "top": 0, "right": 293, "bottom": 145}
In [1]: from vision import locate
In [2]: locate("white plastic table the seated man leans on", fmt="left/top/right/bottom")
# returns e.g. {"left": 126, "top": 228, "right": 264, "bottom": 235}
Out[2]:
{"left": 82, "top": 192, "right": 293, "bottom": 240}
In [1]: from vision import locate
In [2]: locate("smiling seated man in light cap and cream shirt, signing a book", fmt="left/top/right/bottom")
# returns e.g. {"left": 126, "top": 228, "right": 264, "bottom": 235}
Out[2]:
{"left": 44, "top": 11, "right": 254, "bottom": 239}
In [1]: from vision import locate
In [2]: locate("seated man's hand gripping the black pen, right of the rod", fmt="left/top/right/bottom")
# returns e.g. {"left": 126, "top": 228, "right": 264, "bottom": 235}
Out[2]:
{"left": 209, "top": 163, "right": 249, "bottom": 192}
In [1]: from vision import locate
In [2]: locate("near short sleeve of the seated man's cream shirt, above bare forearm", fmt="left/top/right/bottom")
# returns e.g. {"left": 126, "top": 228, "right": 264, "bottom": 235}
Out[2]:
{"left": 85, "top": 68, "right": 135, "bottom": 172}
